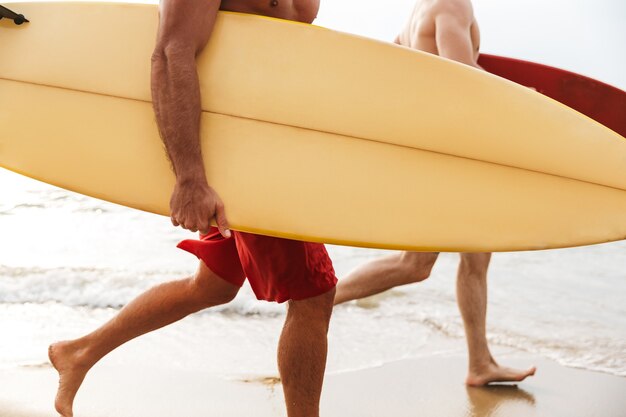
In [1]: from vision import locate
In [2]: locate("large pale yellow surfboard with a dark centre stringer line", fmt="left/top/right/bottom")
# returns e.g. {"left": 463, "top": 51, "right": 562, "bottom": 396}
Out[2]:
{"left": 0, "top": 3, "right": 626, "bottom": 251}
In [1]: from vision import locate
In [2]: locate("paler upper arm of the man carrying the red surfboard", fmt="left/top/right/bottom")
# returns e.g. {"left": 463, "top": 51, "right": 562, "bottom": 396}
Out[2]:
{"left": 435, "top": 0, "right": 482, "bottom": 69}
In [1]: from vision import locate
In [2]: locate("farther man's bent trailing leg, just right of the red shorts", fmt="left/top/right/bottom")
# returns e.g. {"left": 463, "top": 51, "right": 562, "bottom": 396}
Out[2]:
{"left": 335, "top": 252, "right": 439, "bottom": 304}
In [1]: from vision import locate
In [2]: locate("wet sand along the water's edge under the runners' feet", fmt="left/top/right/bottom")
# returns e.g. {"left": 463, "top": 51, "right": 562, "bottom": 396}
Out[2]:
{"left": 0, "top": 356, "right": 626, "bottom": 417}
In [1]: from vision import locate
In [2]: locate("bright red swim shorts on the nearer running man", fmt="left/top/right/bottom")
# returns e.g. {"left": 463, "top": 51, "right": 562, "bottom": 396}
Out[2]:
{"left": 178, "top": 227, "right": 337, "bottom": 303}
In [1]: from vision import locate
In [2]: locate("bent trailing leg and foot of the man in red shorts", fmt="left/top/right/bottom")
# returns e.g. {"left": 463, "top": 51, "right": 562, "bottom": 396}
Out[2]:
{"left": 49, "top": 262, "right": 239, "bottom": 417}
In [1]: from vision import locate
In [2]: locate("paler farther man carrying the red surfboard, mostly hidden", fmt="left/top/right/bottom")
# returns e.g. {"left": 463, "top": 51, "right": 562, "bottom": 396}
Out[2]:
{"left": 335, "top": 0, "right": 535, "bottom": 386}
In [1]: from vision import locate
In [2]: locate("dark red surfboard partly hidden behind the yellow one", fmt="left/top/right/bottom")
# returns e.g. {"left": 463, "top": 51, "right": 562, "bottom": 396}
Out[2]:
{"left": 478, "top": 54, "right": 626, "bottom": 137}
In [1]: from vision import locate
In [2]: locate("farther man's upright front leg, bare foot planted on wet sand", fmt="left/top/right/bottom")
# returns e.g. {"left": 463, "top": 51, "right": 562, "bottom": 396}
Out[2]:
{"left": 456, "top": 253, "right": 535, "bottom": 386}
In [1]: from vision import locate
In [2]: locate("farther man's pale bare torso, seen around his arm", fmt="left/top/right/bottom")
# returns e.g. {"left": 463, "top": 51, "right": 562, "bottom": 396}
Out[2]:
{"left": 395, "top": 0, "right": 480, "bottom": 59}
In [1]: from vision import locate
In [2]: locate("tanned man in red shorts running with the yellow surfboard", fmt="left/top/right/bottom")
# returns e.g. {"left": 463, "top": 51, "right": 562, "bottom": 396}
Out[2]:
{"left": 49, "top": 0, "right": 337, "bottom": 417}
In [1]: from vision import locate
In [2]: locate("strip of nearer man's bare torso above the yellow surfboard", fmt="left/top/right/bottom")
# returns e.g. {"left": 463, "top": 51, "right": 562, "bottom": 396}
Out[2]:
{"left": 220, "top": 0, "right": 320, "bottom": 23}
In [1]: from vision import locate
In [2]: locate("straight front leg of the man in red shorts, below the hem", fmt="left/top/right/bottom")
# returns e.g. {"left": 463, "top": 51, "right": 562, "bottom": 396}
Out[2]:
{"left": 278, "top": 288, "right": 335, "bottom": 417}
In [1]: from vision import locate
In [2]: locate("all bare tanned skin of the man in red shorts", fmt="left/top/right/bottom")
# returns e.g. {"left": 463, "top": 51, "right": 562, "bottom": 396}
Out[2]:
{"left": 49, "top": 0, "right": 335, "bottom": 417}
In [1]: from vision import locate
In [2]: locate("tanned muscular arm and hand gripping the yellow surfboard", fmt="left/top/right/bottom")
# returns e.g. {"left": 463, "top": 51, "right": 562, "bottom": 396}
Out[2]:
{"left": 152, "top": 0, "right": 230, "bottom": 237}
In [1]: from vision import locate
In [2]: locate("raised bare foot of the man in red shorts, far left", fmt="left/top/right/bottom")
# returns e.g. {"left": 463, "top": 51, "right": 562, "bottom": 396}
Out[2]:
{"left": 48, "top": 341, "right": 93, "bottom": 417}
